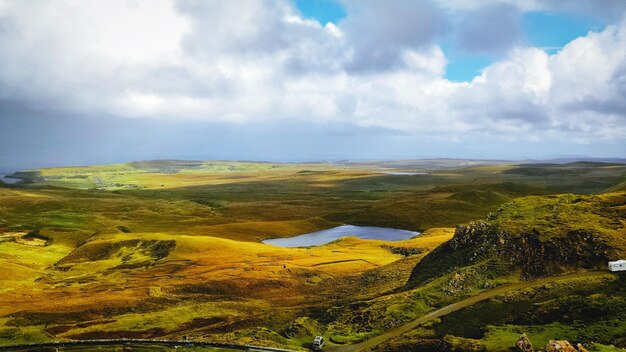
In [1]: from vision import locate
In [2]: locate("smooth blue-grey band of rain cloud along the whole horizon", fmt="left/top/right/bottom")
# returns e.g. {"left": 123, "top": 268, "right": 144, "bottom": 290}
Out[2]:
{"left": 0, "top": 101, "right": 626, "bottom": 172}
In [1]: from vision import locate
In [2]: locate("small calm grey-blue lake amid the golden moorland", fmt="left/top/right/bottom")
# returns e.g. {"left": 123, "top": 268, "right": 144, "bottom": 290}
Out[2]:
{"left": 263, "top": 225, "right": 419, "bottom": 247}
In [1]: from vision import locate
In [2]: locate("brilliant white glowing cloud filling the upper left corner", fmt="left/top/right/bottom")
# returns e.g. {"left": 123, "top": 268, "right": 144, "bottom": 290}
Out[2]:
{"left": 0, "top": 0, "right": 187, "bottom": 111}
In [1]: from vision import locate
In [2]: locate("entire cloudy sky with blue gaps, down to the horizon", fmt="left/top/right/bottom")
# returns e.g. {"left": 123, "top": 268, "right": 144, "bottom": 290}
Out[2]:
{"left": 0, "top": 0, "right": 626, "bottom": 168}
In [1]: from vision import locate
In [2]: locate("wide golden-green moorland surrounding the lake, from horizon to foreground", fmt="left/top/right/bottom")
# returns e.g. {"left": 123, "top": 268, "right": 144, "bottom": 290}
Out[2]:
{"left": 0, "top": 160, "right": 626, "bottom": 351}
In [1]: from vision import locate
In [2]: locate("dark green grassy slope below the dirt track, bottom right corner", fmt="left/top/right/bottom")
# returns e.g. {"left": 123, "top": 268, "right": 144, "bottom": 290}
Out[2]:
{"left": 375, "top": 273, "right": 626, "bottom": 351}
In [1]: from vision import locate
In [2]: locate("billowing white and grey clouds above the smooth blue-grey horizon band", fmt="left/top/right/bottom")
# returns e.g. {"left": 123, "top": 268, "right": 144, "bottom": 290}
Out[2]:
{"left": 0, "top": 0, "right": 626, "bottom": 146}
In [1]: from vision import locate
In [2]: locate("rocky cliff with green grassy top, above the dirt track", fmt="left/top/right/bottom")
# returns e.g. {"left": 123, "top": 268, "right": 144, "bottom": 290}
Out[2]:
{"left": 408, "top": 193, "right": 626, "bottom": 287}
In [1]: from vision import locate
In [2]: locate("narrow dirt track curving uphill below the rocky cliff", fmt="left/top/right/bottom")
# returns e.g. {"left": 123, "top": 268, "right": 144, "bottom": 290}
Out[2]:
{"left": 324, "top": 271, "right": 607, "bottom": 352}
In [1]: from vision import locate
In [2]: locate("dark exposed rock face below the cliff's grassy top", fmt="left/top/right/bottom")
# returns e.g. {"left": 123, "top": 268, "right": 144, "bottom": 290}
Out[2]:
{"left": 408, "top": 221, "right": 612, "bottom": 287}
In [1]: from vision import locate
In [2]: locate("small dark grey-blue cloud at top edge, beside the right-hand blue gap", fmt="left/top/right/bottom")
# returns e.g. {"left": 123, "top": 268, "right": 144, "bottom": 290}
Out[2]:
{"left": 454, "top": 3, "right": 524, "bottom": 54}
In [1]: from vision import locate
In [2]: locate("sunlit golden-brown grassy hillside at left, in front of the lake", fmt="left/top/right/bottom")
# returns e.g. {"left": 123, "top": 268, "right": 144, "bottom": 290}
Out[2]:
{"left": 0, "top": 224, "right": 451, "bottom": 345}
